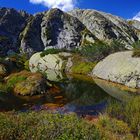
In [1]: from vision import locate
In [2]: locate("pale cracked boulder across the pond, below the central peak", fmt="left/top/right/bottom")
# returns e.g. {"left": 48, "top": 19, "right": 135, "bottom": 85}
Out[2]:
{"left": 29, "top": 52, "right": 71, "bottom": 72}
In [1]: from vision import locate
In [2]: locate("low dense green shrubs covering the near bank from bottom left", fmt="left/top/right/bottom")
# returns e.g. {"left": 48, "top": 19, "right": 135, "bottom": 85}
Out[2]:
{"left": 0, "top": 111, "right": 103, "bottom": 140}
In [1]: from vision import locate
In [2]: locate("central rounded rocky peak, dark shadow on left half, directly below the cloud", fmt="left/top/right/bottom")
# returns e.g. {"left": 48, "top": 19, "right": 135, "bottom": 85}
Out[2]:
{"left": 41, "top": 9, "right": 91, "bottom": 49}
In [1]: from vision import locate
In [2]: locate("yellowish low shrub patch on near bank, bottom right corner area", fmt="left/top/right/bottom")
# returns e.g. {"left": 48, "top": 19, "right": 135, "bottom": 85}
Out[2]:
{"left": 96, "top": 115, "right": 133, "bottom": 140}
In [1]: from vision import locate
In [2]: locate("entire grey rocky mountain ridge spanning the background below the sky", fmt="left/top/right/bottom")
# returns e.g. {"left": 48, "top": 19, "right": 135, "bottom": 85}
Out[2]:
{"left": 0, "top": 8, "right": 140, "bottom": 56}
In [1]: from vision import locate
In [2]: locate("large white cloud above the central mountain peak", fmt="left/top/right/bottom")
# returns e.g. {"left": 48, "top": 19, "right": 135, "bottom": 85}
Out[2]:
{"left": 29, "top": 0, "right": 76, "bottom": 11}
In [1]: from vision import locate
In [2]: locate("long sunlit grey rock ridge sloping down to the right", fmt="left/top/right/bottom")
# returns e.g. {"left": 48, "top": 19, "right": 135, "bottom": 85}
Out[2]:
{"left": 70, "top": 9, "right": 138, "bottom": 49}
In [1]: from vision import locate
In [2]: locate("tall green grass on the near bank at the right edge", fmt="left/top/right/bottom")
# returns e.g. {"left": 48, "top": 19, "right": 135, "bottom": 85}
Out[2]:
{"left": 106, "top": 96, "right": 140, "bottom": 138}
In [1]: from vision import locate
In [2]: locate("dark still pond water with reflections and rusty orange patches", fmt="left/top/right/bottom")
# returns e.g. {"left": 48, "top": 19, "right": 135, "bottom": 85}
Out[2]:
{"left": 0, "top": 72, "right": 137, "bottom": 115}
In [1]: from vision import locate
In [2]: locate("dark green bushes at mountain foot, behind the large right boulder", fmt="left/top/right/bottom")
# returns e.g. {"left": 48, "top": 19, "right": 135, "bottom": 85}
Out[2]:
{"left": 79, "top": 40, "right": 124, "bottom": 61}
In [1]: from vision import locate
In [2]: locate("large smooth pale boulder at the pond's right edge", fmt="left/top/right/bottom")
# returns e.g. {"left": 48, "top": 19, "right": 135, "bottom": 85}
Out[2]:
{"left": 92, "top": 51, "right": 140, "bottom": 88}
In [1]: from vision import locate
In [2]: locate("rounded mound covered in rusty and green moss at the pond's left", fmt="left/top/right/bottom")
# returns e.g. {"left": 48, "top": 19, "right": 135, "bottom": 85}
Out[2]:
{"left": 5, "top": 71, "right": 49, "bottom": 96}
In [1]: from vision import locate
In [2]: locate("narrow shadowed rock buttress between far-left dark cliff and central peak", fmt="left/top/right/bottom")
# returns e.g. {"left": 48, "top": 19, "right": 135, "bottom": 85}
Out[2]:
{"left": 20, "top": 13, "right": 44, "bottom": 56}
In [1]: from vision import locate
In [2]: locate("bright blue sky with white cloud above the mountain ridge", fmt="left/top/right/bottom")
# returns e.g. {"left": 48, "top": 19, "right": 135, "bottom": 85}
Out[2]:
{"left": 0, "top": 0, "right": 140, "bottom": 19}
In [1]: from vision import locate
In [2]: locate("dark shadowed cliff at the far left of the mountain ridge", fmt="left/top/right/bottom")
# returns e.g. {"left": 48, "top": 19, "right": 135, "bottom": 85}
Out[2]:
{"left": 0, "top": 8, "right": 30, "bottom": 56}
